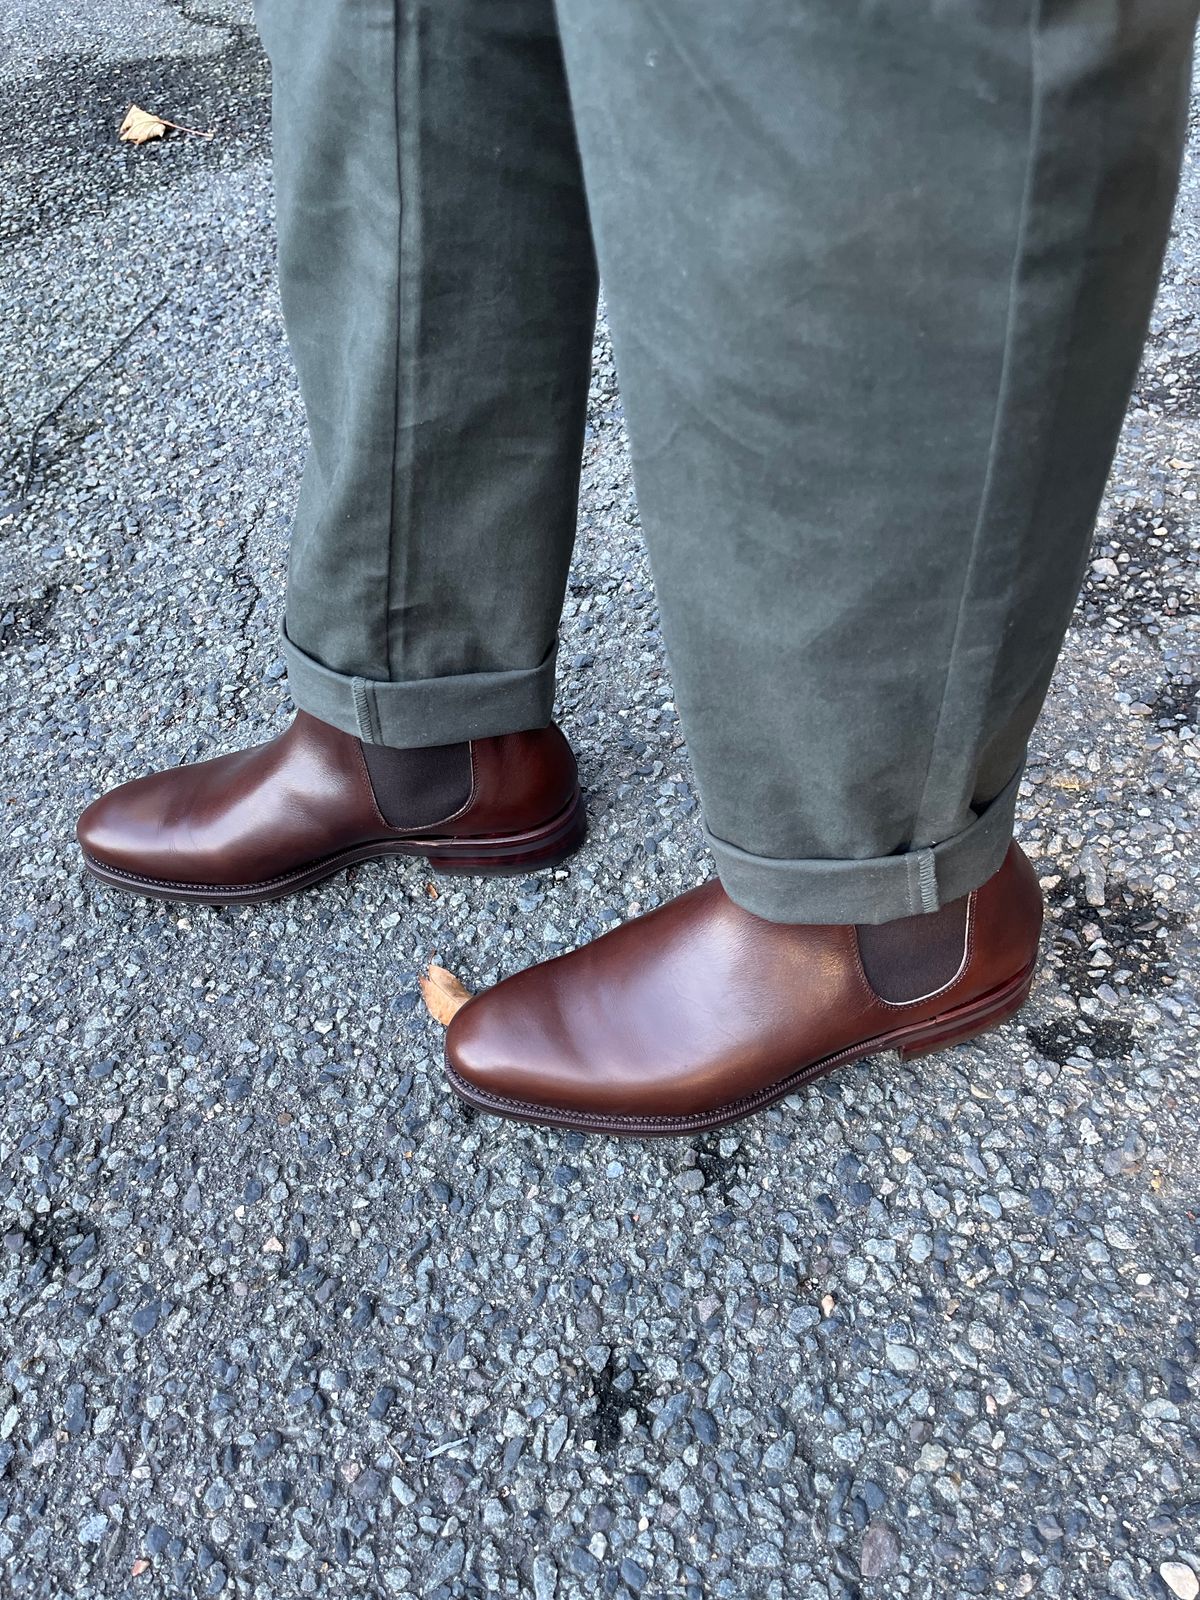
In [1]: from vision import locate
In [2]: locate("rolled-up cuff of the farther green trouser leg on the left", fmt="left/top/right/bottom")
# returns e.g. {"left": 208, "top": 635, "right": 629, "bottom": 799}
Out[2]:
{"left": 282, "top": 632, "right": 558, "bottom": 750}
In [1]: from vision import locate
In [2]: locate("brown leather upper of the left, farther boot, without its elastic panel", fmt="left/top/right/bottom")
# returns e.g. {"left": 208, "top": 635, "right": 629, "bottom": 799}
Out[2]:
{"left": 77, "top": 712, "right": 576, "bottom": 886}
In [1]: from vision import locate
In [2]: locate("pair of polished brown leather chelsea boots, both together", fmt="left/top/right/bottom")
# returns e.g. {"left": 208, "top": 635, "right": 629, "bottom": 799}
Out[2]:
{"left": 78, "top": 712, "right": 1042, "bottom": 1134}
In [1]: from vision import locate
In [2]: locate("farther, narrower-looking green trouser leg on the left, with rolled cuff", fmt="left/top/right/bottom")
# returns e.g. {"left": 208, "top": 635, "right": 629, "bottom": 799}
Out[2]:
{"left": 256, "top": 0, "right": 597, "bottom": 746}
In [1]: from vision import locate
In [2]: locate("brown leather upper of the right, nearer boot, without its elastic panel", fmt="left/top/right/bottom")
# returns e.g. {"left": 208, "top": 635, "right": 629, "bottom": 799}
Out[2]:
{"left": 446, "top": 845, "right": 1042, "bottom": 1117}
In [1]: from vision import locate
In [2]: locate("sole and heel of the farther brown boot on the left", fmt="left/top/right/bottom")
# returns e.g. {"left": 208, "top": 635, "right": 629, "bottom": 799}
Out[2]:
{"left": 83, "top": 789, "right": 587, "bottom": 906}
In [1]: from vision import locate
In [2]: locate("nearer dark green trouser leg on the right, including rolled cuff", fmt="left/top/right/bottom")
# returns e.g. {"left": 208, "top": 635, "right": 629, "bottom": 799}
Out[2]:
{"left": 558, "top": 0, "right": 1195, "bottom": 923}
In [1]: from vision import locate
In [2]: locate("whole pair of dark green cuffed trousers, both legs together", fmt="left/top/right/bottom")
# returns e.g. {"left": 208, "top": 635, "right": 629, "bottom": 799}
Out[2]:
{"left": 258, "top": 0, "right": 1197, "bottom": 923}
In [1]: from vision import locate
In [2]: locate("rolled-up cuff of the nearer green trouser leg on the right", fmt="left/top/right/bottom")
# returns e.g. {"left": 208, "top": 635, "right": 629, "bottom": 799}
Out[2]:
{"left": 704, "top": 768, "right": 1024, "bottom": 923}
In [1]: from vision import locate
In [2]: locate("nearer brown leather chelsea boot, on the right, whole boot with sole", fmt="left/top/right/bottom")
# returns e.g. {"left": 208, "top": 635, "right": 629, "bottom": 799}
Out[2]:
{"left": 446, "top": 845, "right": 1042, "bottom": 1136}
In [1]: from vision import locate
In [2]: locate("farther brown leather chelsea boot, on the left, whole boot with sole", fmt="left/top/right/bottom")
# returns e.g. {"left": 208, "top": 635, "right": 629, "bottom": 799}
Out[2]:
{"left": 75, "top": 712, "right": 587, "bottom": 904}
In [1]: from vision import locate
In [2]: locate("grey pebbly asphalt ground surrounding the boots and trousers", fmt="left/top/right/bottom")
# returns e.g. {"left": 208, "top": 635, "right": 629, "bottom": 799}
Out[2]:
{"left": 0, "top": 0, "right": 1200, "bottom": 1600}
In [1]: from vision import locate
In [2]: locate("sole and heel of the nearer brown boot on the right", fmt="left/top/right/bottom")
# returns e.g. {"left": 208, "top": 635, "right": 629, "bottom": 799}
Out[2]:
{"left": 445, "top": 958, "right": 1037, "bottom": 1139}
